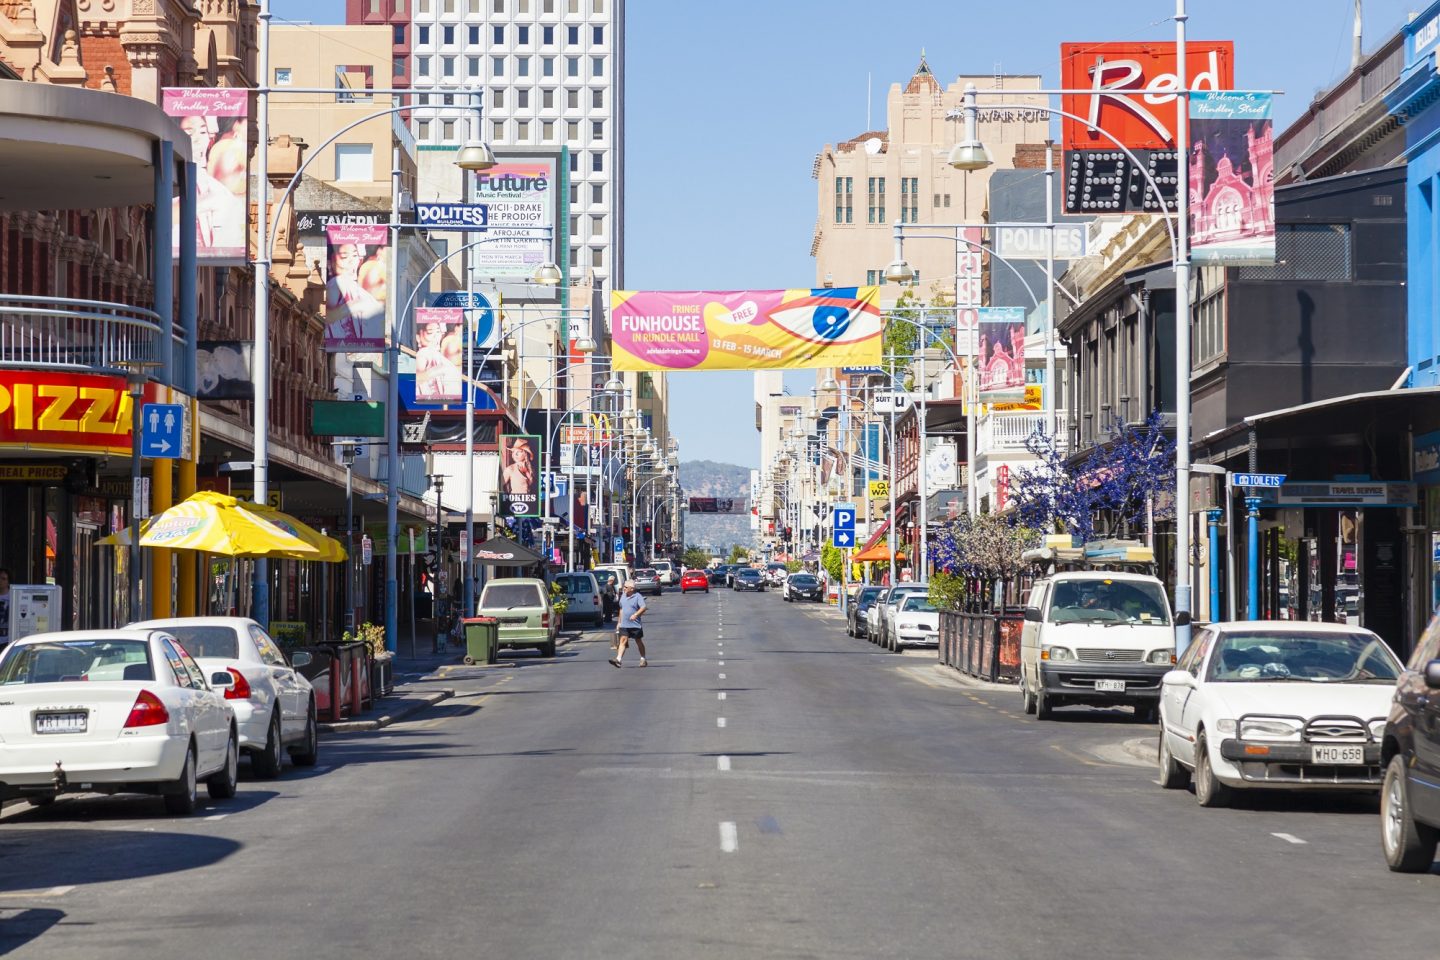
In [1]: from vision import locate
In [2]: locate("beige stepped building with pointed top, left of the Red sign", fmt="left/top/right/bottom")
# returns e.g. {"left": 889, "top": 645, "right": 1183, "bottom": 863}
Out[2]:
{"left": 811, "top": 56, "right": 1050, "bottom": 304}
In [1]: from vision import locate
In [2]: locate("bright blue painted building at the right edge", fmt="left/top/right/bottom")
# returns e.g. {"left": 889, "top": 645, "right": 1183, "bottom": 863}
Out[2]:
{"left": 1385, "top": 1, "right": 1440, "bottom": 387}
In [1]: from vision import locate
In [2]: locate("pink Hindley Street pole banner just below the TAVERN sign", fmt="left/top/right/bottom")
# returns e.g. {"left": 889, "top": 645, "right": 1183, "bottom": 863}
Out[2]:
{"left": 325, "top": 225, "right": 390, "bottom": 353}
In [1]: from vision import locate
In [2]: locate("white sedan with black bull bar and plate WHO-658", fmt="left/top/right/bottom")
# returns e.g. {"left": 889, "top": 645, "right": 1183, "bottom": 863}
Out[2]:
{"left": 1158, "top": 620, "right": 1401, "bottom": 806}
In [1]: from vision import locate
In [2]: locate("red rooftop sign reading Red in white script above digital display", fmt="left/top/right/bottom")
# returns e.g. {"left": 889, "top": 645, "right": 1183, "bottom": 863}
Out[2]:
{"left": 1060, "top": 40, "right": 1236, "bottom": 150}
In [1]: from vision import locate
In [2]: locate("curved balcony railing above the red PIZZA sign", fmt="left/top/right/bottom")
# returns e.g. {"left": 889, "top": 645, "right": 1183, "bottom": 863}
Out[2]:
{"left": 0, "top": 295, "right": 171, "bottom": 376}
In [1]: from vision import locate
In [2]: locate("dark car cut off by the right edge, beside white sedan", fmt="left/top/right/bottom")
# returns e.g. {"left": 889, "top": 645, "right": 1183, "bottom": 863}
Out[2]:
{"left": 1380, "top": 616, "right": 1440, "bottom": 874}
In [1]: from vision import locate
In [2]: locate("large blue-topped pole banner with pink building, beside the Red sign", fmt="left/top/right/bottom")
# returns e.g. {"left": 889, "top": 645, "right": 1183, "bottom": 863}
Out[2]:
{"left": 1189, "top": 92, "right": 1274, "bottom": 263}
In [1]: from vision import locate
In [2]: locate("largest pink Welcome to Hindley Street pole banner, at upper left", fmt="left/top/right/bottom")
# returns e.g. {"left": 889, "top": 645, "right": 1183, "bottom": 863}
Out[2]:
{"left": 161, "top": 88, "right": 249, "bottom": 266}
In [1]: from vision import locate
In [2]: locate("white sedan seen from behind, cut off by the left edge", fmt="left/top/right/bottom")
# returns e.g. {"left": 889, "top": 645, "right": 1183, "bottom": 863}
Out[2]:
{"left": 0, "top": 629, "right": 239, "bottom": 813}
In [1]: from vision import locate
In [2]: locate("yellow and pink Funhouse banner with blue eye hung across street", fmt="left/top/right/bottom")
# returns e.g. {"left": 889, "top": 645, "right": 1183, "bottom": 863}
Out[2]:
{"left": 611, "top": 286, "right": 884, "bottom": 370}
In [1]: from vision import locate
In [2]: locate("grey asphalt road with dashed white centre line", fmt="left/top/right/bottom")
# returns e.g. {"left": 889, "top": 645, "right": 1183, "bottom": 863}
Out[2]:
{"left": 0, "top": 589, "right": 1440, "bottom": 960}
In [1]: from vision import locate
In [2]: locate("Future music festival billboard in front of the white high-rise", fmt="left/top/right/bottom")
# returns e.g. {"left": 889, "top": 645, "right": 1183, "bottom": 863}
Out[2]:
{"left": 475, "top": 157, "right": 556, "bottom": 282}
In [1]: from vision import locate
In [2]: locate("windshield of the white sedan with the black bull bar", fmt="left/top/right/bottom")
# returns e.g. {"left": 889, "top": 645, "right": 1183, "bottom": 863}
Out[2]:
{"left": 1207, "top": 630, "right": 1400, "bottom": 684}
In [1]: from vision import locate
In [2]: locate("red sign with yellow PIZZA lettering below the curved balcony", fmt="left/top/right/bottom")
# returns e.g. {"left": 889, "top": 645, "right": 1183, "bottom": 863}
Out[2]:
{"left": 0, "top": 370, "right": 160, "bottom": 456}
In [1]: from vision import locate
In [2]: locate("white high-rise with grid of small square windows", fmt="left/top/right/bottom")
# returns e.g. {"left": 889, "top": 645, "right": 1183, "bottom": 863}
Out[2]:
{"left": 410, "top": 0, "right": 625, "bottom": 284}
